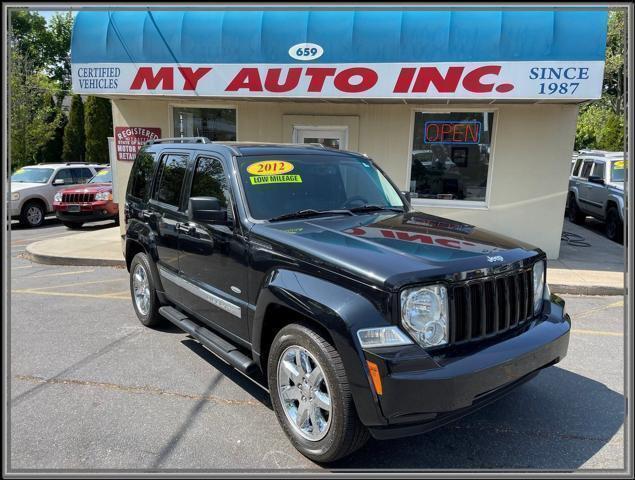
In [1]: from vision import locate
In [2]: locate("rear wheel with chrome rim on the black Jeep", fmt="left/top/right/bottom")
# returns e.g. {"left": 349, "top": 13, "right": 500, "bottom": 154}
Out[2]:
{"left": 130, "top": 252, "right": 164, "bottom": 327}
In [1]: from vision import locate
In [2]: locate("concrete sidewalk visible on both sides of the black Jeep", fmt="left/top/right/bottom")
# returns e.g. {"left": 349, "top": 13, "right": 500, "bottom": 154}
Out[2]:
{"left": 26, "top": 220, "right": 624, "bottom": 295}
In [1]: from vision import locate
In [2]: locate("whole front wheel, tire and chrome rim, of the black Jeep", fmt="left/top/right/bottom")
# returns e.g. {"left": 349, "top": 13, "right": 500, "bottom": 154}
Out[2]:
{"left": 267, "top": 324, "right": 369, "bottom": 462}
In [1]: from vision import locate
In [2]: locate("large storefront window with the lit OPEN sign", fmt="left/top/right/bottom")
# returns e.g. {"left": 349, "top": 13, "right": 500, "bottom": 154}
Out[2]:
{"left": 410, "top": 112, "right": 494, "bottom": 202}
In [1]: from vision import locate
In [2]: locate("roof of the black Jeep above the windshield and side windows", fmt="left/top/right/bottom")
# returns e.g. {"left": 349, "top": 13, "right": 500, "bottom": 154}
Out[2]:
{"left": 147, "top": 139, "right": 367, "bottom": 158}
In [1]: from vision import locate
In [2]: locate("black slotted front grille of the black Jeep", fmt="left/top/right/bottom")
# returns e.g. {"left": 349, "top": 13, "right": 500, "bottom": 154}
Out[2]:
{"left": 450, "top": 269, "right": 533, "bottom": 345}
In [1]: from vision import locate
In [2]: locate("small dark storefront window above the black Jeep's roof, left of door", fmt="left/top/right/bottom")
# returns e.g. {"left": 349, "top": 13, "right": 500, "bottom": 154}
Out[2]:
{"left": 172, "top": 107, "right": 236, "bottom": 142}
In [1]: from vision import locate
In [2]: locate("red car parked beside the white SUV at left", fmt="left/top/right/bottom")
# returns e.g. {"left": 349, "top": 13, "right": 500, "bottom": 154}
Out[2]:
{"left": 53, "top": 168, "right": 119, "bottom": 228}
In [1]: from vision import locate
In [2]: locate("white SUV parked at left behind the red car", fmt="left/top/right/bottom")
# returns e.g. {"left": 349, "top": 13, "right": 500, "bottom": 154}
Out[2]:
{"left": 9, "top": 162, "right": 108, "bottom": 227}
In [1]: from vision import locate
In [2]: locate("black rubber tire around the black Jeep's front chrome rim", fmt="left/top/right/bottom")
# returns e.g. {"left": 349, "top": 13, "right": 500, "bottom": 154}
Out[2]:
{"left": 267, "top": 324, "right": 370, "bottom": 463}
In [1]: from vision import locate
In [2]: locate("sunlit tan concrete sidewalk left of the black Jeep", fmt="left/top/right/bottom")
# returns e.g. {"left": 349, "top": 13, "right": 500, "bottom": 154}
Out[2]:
{"left": 26, "top": 227, "right": 126, "bottom": 266}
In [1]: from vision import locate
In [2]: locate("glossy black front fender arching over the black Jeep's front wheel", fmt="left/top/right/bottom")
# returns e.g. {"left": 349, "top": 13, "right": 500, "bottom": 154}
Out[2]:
{"left": 252, "top": 270, "right": 387, "bottom": 426}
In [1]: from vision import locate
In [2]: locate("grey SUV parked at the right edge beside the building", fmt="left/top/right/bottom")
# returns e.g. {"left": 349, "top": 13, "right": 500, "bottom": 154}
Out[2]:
{"left": 567, "top": 150, "right": 627, "bottom": 242}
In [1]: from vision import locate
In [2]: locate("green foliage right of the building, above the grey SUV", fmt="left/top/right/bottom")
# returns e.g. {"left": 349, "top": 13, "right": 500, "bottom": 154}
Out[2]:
{"left": 575, "top": 10, "right": 626, "bottom": 151}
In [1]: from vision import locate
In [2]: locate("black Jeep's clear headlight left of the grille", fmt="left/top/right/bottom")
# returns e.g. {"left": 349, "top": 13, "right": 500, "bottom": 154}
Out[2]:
{"left": 401, "top": 285, "right": 448, "bottom": 347}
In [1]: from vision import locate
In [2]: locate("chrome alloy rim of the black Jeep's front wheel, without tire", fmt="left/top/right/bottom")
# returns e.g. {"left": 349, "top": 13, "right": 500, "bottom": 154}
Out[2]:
{"left": 278, "top": 345, "right": 331, "bottom": 442}
